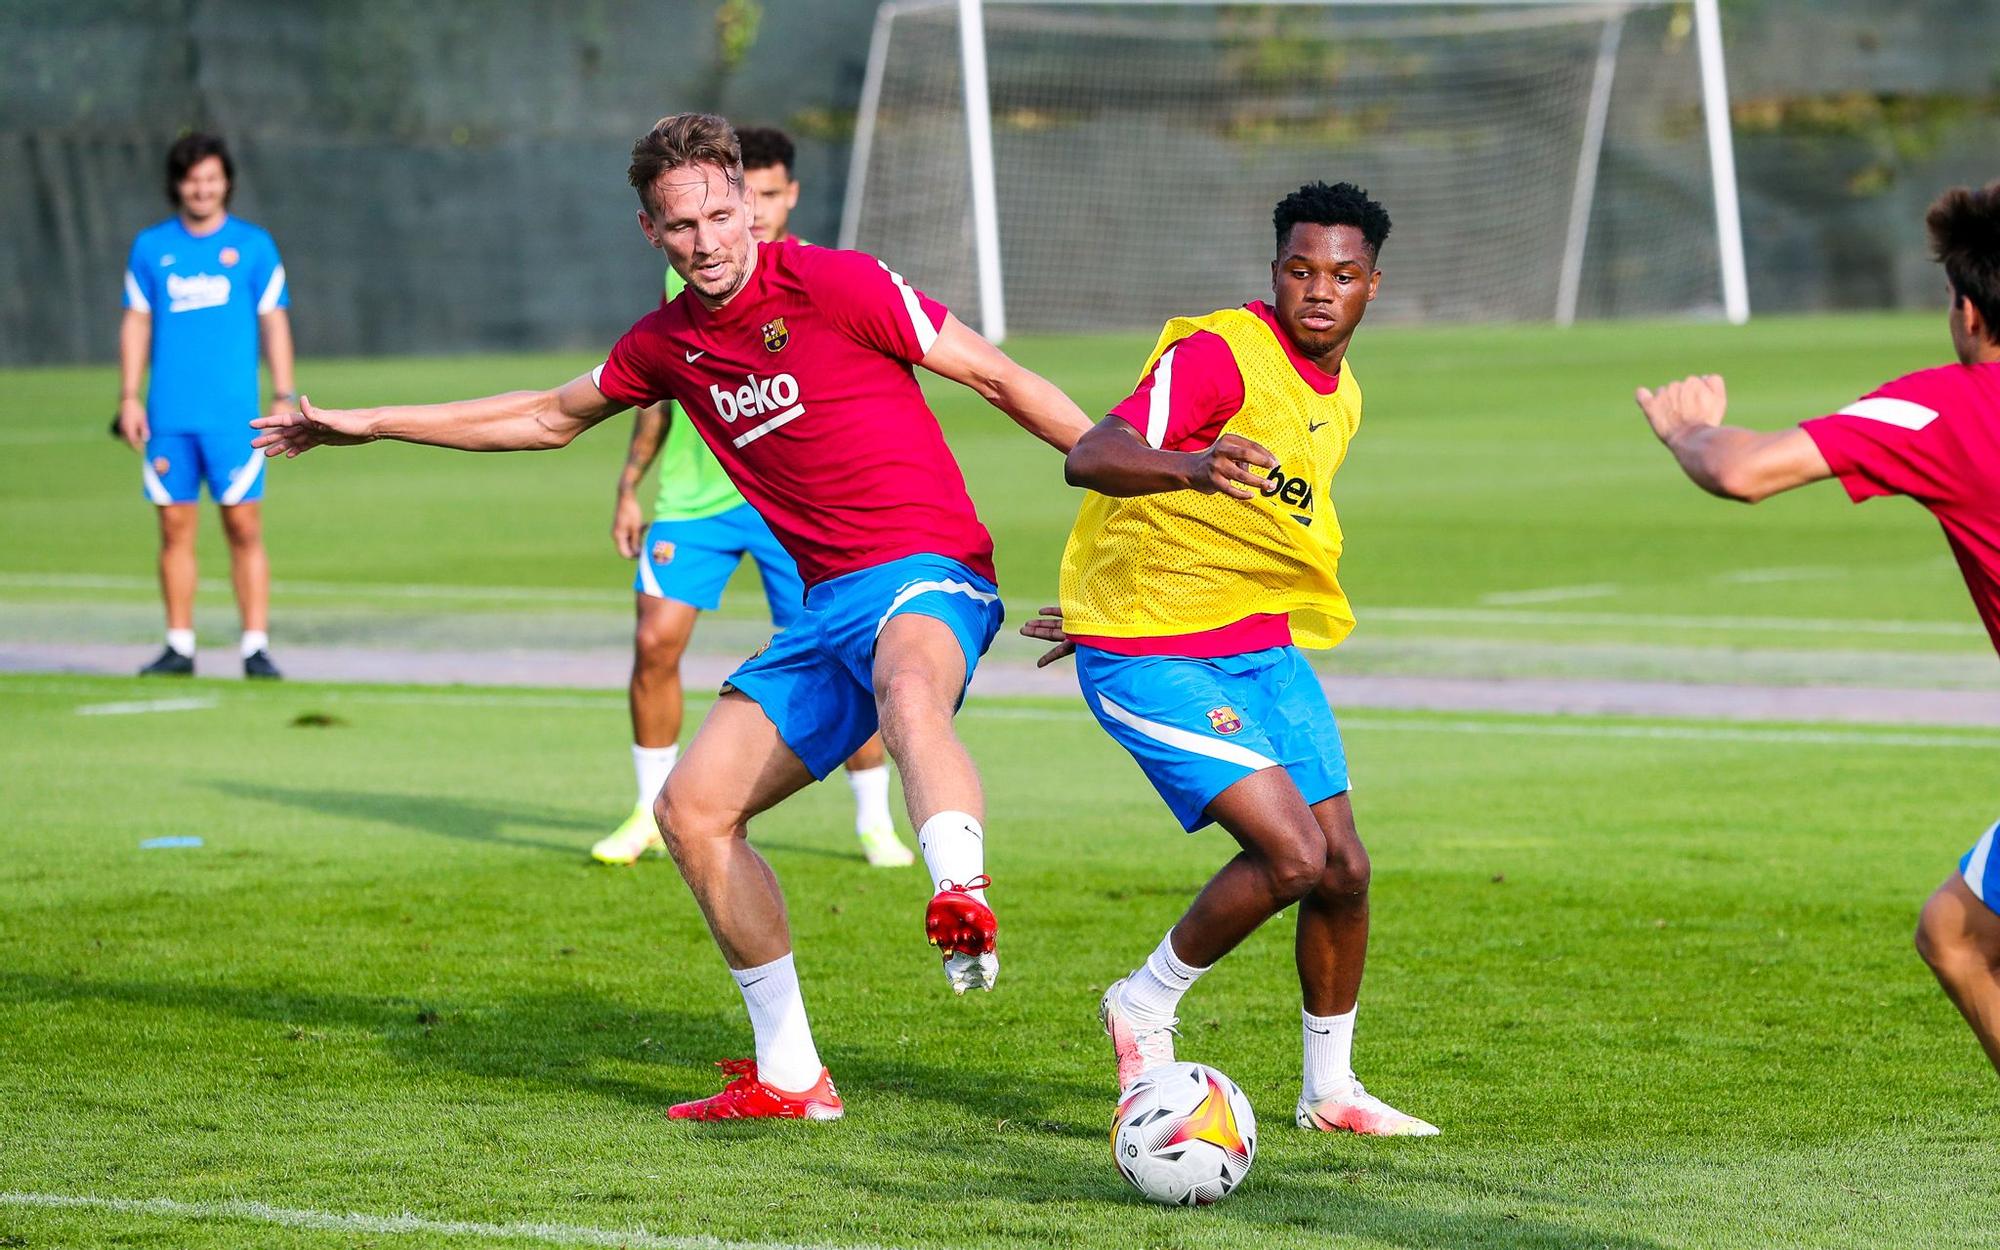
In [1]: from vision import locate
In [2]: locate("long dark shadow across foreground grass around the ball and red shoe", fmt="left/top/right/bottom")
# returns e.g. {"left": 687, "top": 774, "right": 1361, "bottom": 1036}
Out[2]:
{"left": 0, "top": 974, "right": 1656, "bottom": 1250}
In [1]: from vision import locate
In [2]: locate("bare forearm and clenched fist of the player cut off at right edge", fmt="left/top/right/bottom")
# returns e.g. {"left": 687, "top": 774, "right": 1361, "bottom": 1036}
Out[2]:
{"left": 1636, "top": 374, "right": 1834, "bottom": 504}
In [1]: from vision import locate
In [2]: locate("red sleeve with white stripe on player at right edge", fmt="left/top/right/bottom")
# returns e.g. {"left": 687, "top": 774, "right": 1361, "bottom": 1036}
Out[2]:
{"left": 1800, "top": 370, "right": 1958, "bottom": 504}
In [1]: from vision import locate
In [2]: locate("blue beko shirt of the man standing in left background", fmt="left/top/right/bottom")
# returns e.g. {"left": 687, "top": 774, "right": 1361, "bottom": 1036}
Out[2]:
{"left": 126, "top": 216, "right": 292, "bottom": 434}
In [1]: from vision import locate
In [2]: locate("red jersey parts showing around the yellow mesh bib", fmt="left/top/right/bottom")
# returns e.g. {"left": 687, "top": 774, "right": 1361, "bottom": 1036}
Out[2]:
{"left": 1076, "top": 300, "right": 1340, "bottom": 658}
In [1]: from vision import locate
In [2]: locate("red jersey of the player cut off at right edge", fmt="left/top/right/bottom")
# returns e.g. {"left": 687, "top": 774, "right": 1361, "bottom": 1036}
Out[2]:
{"left": 1802, "top": 364, "right": 2000, "bottom": 650}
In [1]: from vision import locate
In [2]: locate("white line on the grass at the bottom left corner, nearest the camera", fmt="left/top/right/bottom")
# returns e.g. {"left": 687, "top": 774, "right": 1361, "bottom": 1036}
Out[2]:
{"left": 0, "top": 1192, "right": 892, "bottom": 1250}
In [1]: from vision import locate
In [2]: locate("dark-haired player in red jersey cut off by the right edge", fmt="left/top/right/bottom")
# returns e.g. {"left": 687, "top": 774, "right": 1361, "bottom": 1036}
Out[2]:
{"left": 1638, "top": 182, "right": 2000, "bottom": 1070}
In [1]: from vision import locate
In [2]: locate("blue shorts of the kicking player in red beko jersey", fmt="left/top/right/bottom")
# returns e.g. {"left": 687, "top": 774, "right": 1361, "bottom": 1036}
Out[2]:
{"left": 722, "top": 556, "right": 1004, "bottom": 778}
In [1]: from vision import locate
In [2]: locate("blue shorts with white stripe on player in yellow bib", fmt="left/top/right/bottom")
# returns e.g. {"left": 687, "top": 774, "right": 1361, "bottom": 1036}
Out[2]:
{"left": 1076, "top": 646, "right": 1348, "bottom": 834}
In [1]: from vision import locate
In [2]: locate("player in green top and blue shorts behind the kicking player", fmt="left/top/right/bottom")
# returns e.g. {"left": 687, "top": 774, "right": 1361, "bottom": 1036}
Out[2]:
{"left": 590, "top": 128, "right": 916, "bottom": 868}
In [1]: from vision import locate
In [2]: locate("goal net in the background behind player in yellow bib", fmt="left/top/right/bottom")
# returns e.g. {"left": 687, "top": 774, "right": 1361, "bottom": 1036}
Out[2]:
{"left": 842, "top": 0, "right": 1734, "bottom": 332}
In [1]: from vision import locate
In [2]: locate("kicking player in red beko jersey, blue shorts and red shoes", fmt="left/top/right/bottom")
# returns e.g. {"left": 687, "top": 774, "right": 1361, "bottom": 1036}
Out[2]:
{"left": 256, "top": 114, "right": 1090, "bottom": 1120}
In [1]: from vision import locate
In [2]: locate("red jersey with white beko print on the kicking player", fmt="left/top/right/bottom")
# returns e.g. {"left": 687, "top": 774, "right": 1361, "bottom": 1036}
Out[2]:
{"left": 592, "top": 240, "right": 994, "bottom": 586}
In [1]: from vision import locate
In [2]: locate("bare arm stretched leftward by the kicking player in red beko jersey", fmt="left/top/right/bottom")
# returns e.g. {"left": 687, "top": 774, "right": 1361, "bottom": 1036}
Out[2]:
{"left": 250, "top": 374, "right": 626, "bottom": 456}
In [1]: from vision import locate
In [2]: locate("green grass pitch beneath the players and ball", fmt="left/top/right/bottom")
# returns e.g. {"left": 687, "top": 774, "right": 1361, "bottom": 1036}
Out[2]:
{"left": 0, "top": 316, "right": 2000, "bottom": 1250}
